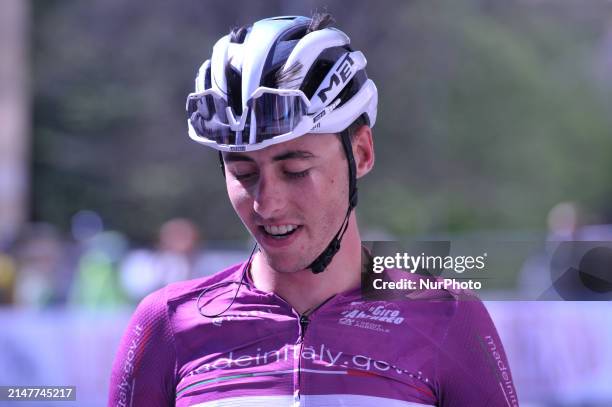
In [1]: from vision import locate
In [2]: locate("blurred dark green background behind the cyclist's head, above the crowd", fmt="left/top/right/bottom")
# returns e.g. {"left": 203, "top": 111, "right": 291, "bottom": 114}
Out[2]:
{"left": 26, "top": 0, "right": 612, "bottom": 242}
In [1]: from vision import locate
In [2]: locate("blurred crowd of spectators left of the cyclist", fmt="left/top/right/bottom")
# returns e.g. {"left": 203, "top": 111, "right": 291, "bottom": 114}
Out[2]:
{"left": 0, "top": 211, "right": 244, "bottom": 308}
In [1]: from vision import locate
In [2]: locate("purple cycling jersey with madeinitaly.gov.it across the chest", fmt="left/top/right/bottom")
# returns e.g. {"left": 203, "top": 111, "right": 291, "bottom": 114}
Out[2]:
{"left": 108, "top": 264, "right": 518, "bottom": 407}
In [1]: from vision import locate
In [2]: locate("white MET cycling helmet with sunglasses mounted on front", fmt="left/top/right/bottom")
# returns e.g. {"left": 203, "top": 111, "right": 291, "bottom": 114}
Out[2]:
{"left": 187, "top": 15, "right": 378, "bottom": 151}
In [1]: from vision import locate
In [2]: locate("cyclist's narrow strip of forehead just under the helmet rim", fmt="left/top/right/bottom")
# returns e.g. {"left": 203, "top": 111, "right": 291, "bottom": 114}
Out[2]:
{"left": 223, "top": 134, "right": 341, "bottom": 161}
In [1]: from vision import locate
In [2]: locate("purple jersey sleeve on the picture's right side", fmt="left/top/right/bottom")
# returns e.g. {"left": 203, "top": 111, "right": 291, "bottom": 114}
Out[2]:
{"left": 436, "top": 299, "right": 519, "bottom": 407}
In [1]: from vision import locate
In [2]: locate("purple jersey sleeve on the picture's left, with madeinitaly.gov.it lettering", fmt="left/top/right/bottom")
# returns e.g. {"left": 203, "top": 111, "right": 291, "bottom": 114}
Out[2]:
{"left": 108, "top": 289, "right": 176, "bottom": 407}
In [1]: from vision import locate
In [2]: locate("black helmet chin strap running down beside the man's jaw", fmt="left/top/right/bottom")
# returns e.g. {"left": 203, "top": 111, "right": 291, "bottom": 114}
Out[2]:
{"left": 308, "top": 130, "right": 357, "bottom": 274}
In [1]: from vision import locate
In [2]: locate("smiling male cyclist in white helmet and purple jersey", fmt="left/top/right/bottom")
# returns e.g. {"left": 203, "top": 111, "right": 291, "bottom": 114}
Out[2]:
{"left": 109, "top": 15, "right": 518, "bottom": 407}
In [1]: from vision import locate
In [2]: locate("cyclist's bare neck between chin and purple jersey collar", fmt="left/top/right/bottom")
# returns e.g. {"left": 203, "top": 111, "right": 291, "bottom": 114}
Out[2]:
{"left": 251, "top": 212, "right": 361, "bottom": 314}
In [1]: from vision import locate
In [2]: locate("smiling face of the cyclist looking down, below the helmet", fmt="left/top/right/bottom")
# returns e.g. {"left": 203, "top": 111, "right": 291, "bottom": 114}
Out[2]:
{"left": 223, "top": 134, "right": 348, "bottom": 272}
